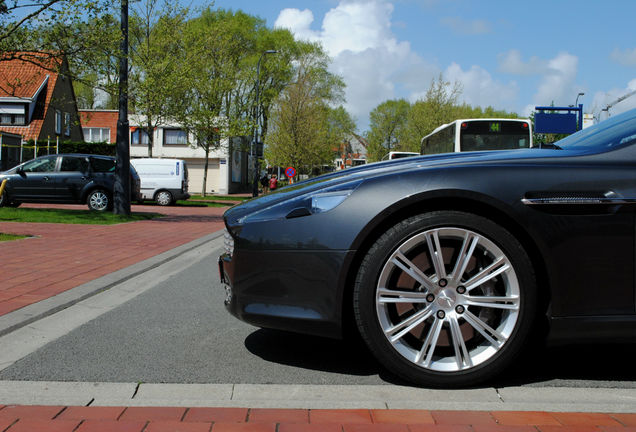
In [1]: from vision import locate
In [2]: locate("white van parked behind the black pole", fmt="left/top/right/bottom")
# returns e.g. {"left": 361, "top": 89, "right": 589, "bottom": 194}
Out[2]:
{"left": 130, "top": 158, "right": 190, "bottom": 205}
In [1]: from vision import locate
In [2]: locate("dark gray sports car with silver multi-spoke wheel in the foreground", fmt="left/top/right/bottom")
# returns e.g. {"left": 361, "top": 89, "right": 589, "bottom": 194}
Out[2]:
{"left": 219, "top": 110, "right": 636, "bottom": 387}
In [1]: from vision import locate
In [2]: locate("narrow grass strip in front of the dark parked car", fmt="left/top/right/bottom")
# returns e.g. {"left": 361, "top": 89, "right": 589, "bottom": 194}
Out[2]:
{"left": 0, "top": 207, "right": 162, "bottom": 225}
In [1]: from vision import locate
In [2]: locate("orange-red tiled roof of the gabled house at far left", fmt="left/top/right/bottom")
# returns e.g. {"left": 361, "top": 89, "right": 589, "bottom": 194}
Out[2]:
{"left": 0, "top": 52, "right": 61, "bottom": 140}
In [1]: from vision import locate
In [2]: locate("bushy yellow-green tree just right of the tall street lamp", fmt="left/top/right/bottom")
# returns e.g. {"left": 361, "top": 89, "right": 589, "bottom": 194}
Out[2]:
{"left": 265, "top": 42, "right": 350, "bottom": 177}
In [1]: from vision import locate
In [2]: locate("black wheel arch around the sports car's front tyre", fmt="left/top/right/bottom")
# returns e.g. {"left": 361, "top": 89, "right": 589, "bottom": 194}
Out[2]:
{"left": 340, "top": 194, "right": 551, "bottom": 337}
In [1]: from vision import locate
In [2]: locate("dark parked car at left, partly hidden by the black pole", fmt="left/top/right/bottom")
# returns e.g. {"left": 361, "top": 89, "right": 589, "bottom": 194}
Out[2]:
{"left": 0, "top": 154, "right": 139, "bottom": 211}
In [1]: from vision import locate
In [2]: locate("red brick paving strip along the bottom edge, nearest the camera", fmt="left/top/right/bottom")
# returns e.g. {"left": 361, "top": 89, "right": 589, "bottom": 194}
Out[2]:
{"left": 0, "top": 405, "right": 636, "bottom": 432}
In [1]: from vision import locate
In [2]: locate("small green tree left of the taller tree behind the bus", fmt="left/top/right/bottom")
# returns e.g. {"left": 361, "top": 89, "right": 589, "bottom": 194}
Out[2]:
{"left": 366, "top": 99, "right": 411, "bottom": 162}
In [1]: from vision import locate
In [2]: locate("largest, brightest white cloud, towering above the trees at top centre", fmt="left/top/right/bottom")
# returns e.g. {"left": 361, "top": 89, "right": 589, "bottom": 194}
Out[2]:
{"left": 274, "top": 0, "right": 439, "bottom": 128}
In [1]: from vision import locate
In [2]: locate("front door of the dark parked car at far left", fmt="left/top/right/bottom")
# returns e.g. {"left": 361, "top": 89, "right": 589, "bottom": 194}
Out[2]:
{"left": 11, "top": 155, "right": 58, "bottom": 201}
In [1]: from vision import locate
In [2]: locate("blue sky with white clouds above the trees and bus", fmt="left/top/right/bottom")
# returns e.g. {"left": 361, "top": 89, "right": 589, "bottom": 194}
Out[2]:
{"left": 194, "top": 0, "right": 636, "bottom": 130}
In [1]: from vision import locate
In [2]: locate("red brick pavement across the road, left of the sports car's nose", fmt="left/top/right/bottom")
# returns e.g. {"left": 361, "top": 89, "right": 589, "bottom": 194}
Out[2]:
{"left": 0, "top": 204, "right": 227, "bottom": 318}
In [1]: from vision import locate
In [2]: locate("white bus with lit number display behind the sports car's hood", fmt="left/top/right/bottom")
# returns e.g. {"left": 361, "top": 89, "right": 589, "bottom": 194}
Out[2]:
{"left": 422, "top": 119, "right": 532, "bottom": 154}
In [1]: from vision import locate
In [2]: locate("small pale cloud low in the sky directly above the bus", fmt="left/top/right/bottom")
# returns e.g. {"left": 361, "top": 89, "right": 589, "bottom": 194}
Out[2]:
{"left": 444, "top": 63, "right": 519, "bottom": 111}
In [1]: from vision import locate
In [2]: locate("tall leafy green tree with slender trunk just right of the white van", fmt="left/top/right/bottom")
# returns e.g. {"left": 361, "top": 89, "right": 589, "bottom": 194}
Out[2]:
{"left": 171, "top": 8, "right": 263, "bottom": 194}
